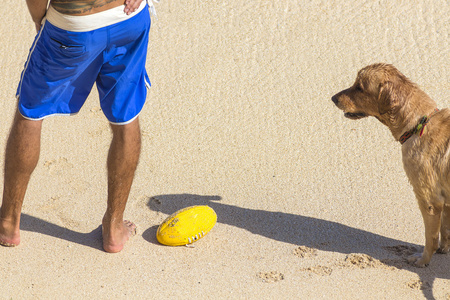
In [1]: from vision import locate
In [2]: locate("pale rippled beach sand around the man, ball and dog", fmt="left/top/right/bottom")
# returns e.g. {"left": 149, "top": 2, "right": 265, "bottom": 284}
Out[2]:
{"left": 0, "top": 0, "right": 450, "bottom": 300}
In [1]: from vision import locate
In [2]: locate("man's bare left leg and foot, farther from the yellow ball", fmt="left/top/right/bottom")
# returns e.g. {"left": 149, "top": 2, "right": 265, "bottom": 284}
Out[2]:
{"left": 0, "top": 112, "right": 42, "bottom": 246}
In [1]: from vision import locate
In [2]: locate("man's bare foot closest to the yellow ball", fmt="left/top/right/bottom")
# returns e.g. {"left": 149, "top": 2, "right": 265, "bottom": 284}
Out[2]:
{"left": 102, "top": 221, "right": 136, "bottom": 253}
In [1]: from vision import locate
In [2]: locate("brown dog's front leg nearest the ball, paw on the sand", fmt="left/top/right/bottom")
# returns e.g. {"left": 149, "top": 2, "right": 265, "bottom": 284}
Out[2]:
{"left": 408, "top": 200, "right": 442, "bottom": 268}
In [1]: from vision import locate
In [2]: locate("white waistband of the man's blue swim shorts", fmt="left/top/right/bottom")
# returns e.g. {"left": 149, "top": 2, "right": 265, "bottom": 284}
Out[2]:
{"left": 45, "top": 1, "right": 147, "bottom": 32}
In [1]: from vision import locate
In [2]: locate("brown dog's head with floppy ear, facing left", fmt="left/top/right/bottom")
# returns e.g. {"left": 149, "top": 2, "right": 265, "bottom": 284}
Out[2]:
{"left": 331, "top": 64, "right": 412, "bottom": 125}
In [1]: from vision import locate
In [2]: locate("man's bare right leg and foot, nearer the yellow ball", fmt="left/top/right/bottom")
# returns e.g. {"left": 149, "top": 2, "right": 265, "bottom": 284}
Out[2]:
{"left": 102, "top": 119, "right": 141, "bottom": 253}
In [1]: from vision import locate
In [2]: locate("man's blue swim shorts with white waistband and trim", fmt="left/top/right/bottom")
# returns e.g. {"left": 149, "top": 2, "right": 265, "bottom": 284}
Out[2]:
{"left": 16, "top": 1, "right": 150, "bottom": 124}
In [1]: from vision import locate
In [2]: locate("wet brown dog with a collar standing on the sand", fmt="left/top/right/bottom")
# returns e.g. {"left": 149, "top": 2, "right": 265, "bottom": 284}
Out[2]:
{"left": 332, "top": 64, "right": 450, "bottom": 267}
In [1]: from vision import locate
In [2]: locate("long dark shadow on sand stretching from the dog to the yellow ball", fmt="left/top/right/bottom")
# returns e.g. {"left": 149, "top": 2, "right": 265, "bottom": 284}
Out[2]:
{"left": 143, "top": 194, "right": 450, "bottom": 299}
